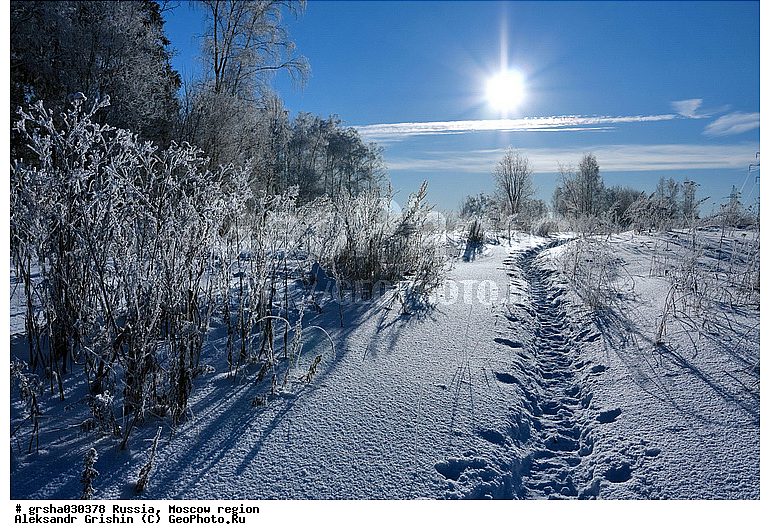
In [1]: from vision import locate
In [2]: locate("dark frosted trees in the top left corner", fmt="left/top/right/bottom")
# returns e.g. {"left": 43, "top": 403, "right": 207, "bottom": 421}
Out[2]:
{"left": 11, "top": 0, "right": 180, "bottom": 147}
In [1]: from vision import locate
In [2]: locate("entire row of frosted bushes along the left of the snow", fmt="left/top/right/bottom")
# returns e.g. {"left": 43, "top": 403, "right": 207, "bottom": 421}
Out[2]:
{"left": 10, "top": 98, "right": 444, "bottom": 448}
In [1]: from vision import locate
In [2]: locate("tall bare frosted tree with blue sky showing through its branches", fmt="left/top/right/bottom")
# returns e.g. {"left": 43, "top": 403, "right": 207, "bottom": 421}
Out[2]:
{"left": 180, "top": 0, "right": 309, "bottom": 166}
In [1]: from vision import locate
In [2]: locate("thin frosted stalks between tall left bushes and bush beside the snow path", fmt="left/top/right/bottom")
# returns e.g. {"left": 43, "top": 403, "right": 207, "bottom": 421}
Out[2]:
{"left": 216, "top": 188, "right": 315, "bottom": 374}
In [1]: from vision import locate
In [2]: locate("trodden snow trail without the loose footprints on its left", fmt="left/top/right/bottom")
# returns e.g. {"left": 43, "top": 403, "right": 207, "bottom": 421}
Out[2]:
{"left": 510, "top": 242, "right": 631, "bottom": 499}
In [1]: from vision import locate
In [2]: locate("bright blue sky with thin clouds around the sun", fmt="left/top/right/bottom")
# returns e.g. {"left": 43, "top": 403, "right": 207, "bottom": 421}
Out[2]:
{"left": 166, "top": 0, "right": 760, "bottom": 209}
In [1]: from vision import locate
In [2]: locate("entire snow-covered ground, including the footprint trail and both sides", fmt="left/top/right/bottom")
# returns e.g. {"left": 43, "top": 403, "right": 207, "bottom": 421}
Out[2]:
{"left": 11, "top": 228, "right": 759, "bottom": 499}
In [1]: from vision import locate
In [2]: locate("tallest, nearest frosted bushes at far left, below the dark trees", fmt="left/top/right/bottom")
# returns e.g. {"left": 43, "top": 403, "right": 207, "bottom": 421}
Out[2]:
{"left": 11, "top": 100, "right": 234, "bottom": 445}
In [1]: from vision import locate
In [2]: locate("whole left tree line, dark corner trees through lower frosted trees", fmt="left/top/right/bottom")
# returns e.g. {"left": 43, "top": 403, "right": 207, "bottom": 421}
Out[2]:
{"left": 10, "top": 0, "right": 385, "bottom": 201}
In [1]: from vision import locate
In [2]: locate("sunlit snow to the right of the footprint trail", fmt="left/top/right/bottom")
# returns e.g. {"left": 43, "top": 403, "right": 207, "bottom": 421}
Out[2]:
{"left": 544, "top": 232, "right": 760, "bottom": 499}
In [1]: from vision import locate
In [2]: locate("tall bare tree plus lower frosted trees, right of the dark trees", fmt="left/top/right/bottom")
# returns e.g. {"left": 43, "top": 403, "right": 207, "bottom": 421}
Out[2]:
{"left": 174, "top": 0, "right": 385, "bottom": 196}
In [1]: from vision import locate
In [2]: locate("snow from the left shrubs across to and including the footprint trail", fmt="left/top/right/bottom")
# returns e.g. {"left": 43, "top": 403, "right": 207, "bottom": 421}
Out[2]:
{"left": 6, "top": 236, "right": 622, "bottom": 499}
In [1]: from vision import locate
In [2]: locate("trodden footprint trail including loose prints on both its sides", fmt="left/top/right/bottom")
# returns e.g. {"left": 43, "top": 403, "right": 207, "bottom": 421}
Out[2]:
{"left": 436, "top": 241, "right": 640, "bottom": 499}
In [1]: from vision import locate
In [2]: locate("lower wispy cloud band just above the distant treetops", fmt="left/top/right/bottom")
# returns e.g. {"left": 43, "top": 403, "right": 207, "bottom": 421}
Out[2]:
{"left": 386, "top": 143, "right": 757, "bottom": 174}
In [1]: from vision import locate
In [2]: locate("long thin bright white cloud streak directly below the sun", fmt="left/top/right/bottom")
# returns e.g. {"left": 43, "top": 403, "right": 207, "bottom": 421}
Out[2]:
{"left": 355, "top": 114, "right": 678, "bottom": 141}
